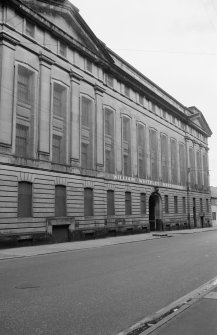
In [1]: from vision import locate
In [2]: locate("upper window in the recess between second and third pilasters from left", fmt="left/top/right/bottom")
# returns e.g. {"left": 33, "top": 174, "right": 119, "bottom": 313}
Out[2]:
{"left": 53, "top": 83, "right": 66, "bottom": 117}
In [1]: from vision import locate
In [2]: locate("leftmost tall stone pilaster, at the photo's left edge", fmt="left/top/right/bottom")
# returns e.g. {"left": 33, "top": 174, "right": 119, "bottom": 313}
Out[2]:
{"left": 0, "top": 31, "right": 19, "bottom": 147}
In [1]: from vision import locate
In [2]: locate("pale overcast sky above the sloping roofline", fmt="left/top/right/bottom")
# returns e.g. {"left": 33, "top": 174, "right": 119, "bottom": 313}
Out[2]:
{"left": 70, "top": 0, "right": 217, "bottom": 186}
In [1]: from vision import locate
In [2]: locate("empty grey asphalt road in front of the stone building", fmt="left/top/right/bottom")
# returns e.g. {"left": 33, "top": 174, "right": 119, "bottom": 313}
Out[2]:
{"left": 0, "top": 231, "right": 217, "bottom": 335}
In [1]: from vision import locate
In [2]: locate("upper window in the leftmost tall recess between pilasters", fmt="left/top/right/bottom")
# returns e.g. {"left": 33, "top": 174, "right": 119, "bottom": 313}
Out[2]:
{"left": 17, "top": 66, "right": 32, "bottom": 104}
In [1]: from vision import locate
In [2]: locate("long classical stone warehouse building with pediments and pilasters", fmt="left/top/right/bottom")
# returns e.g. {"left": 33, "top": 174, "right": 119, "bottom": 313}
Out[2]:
{"left": 0, "top": 0, "right": 211, "bottom": 243}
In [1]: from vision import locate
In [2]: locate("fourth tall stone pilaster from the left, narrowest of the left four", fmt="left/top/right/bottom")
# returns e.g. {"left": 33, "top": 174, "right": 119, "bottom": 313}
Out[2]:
{"left": 95, "top": 85, "right": 105, "bottom": 171}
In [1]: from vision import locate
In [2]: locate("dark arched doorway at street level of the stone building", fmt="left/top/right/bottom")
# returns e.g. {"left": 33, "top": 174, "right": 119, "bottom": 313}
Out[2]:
{"left": 149, "top": 192, "right": 163, "bottom": 231}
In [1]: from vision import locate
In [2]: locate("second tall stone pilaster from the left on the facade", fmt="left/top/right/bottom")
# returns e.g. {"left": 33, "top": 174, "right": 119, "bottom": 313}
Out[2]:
{"left": 38, "top": 54, "right": 54, "bottom": 160}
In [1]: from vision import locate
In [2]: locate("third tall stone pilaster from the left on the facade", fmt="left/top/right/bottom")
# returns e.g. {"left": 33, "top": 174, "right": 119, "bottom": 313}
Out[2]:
{"left": 70, "top": 70, "right": 83, "bottom": 167}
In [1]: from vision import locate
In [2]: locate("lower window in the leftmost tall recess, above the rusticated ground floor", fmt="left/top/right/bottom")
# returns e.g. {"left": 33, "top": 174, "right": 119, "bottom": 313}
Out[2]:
{"left": 15, "top": 123, "right": 29, "bottom": 158}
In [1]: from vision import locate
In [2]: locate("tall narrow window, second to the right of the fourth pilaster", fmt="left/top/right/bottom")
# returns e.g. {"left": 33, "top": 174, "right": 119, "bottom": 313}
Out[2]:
{"left": 122, "top": 116, "right": 131, "bottom": 176}
